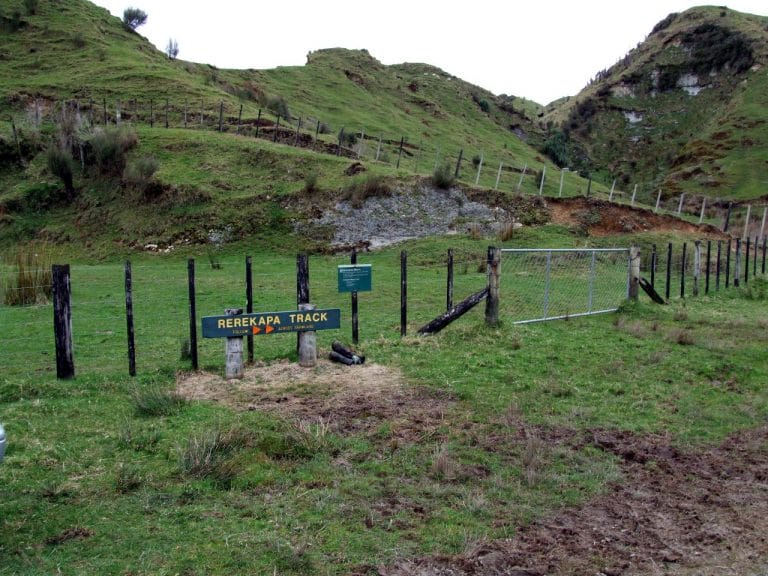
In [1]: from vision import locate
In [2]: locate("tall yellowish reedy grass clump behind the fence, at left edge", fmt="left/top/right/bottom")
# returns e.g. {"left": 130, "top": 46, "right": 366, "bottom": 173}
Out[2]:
{"left": 0, "top": 244, "right": 53, "bottom": 306}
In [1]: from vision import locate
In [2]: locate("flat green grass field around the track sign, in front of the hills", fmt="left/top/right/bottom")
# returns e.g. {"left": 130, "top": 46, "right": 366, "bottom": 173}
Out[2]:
{"left": 0, "top": 229, "right": 768, "bottom": 574}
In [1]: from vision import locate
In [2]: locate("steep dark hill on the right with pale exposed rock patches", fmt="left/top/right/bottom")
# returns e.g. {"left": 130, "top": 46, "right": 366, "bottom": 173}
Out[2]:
{"left": 544, "top": 7, "right": 768, "bottom": 199}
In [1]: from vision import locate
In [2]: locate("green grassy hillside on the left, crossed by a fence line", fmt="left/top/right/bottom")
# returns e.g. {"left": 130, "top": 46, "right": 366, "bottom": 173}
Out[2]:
{"left": 0, "top": 0, "right": 612, "bottom": 246}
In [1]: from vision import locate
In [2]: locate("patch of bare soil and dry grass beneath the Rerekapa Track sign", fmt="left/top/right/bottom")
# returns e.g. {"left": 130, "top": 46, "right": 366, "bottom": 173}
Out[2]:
{"left": 177, "top": 360, "right": 452, "bottom": 441}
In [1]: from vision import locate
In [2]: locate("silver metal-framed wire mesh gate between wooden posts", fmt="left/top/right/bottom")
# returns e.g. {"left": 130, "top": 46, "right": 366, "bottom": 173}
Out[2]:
{"left": 501, "top": 248, "right": 630, "bottom": 324}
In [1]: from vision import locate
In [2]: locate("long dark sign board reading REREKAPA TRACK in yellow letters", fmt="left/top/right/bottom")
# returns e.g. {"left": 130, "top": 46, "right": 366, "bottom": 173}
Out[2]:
{"left": 203, "top": 308, "right": 341, "bottom": 338}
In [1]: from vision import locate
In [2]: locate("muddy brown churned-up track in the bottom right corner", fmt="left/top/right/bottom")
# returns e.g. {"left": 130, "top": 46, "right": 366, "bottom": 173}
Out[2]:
{"left": 379, "top": 426, "right": 768, "bottom": 576}
